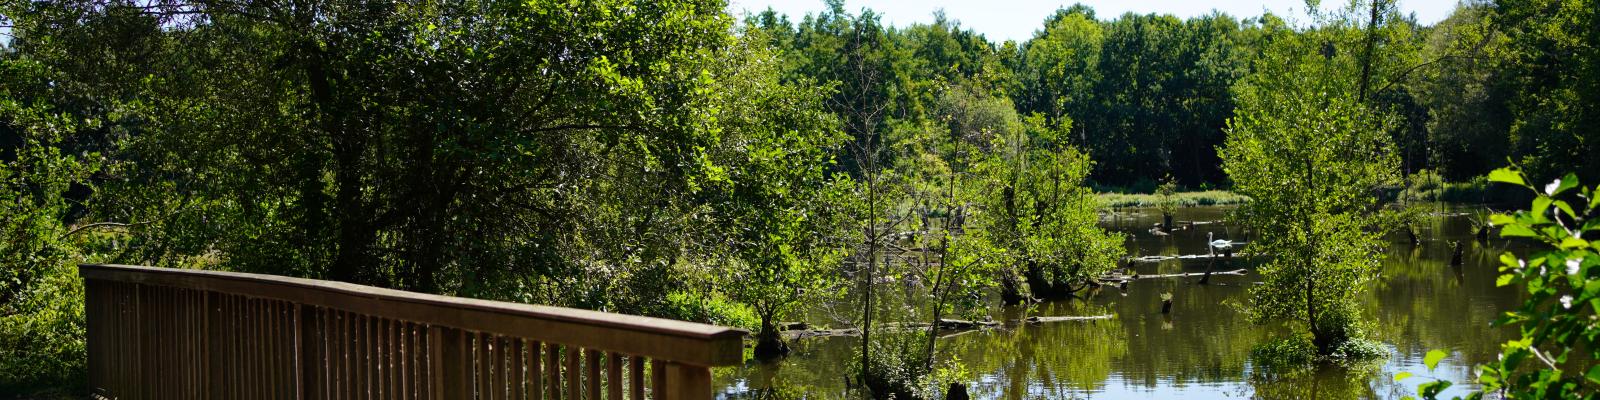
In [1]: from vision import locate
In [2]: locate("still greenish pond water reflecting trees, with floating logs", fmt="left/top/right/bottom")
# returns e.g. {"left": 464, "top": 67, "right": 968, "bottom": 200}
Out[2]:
{"left": 714, "top": 205, "right": 1523, "bottom": 400}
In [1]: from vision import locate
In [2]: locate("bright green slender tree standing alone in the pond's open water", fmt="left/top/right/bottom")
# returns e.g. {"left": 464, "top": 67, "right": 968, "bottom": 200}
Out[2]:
{"left": 1219, "top": 13, "right": 1400, "bottom": 355}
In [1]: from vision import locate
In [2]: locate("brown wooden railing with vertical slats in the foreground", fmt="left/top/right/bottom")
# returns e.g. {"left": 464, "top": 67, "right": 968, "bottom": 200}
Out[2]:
{"left": 80, "top": 266, "right": 746, "bottom": 400}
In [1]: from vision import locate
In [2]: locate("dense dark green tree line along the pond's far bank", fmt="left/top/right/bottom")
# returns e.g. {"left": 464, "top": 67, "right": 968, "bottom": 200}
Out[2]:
{"left": 746, "top": 2, "right": 1600, "bottom": 187}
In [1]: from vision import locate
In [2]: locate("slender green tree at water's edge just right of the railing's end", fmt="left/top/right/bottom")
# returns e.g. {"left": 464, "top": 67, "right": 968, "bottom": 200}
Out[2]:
{"left": 706, "top": 30, "right": 851, "bottom": 358}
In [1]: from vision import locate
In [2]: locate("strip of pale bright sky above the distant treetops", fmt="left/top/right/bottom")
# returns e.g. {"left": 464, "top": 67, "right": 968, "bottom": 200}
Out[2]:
{"left": 728, "top": 0, "right": 1458, "bottom": 43}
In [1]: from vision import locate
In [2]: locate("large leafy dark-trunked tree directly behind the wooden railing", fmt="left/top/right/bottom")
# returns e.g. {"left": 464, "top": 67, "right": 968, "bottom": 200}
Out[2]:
{"left": 7, "top": 2, "right": 731, "bottom": 315}
